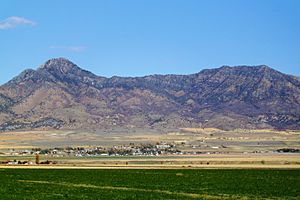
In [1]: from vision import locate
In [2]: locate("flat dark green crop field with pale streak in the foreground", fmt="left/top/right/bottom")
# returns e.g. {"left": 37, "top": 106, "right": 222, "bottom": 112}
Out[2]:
{"left": 0, "top": 169, "right": 300, "bottom": 199}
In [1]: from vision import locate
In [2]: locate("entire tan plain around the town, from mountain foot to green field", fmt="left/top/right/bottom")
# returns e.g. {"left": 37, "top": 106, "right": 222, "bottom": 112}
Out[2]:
{"left": 0, "top": 128, "right": 300, "bottom": 168}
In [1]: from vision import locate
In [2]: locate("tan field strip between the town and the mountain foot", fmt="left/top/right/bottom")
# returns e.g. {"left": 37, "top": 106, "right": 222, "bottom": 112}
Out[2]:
{"left": 0, "top": 128, "right": 300, "bottom": 153}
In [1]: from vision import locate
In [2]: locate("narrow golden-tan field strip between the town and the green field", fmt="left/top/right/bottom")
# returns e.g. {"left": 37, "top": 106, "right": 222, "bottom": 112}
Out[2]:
{"left": 0, "top": 154, "right": 300, "bottom": 169}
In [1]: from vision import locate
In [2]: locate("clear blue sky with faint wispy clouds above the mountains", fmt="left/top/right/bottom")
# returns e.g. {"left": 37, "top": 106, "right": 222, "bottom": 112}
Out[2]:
{"left": 0, "top": 0, "right": 300, "bottom": 84}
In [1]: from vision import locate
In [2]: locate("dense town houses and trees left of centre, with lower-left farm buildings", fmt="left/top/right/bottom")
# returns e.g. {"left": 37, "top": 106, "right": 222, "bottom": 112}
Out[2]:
{"left": 0, "top": 142, "right": 183, "bottom": 165}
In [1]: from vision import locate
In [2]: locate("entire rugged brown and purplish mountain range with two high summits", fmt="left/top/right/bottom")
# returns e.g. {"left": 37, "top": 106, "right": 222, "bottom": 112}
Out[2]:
{"left": 0, "top": 58, "right": 300, "bottom": 131}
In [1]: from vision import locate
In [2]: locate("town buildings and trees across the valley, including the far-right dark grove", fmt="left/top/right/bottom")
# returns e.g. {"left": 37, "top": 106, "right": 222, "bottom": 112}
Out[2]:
{"left": 0, "top": 141, "right": 300, "bottom": 165}
